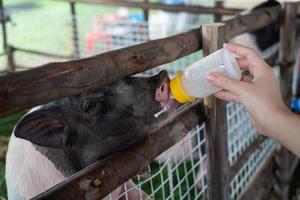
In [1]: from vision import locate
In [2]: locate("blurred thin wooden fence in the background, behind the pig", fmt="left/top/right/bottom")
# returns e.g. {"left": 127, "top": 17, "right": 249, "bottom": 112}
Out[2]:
{"left": 0, "top": 0, "right": 242, "bottom": 72}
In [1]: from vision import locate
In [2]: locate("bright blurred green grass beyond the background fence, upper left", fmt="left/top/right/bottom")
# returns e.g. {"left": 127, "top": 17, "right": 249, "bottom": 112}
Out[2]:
{"left": 0, "top": 0, "right": 122, "bottom": 70}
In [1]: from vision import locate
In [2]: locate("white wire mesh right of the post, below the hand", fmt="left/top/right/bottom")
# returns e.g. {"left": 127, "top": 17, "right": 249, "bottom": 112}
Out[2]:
{"left": 227, "top": 103, "right": 277, "bottom": 199}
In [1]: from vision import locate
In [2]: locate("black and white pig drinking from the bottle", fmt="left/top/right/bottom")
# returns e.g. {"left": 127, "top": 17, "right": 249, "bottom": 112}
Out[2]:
{"left": 6, "top": 71, "right": 174, "bottom": 200}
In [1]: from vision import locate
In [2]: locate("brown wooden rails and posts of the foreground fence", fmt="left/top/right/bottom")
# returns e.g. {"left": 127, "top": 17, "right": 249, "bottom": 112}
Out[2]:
{"left": 0, "top": 0, "right": 299, "bottom": 200}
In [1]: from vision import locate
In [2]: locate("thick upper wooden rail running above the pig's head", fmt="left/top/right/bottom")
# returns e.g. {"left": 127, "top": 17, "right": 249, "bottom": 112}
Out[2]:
{"left": 0, "top": 7, "right": 280, "bottom": 117}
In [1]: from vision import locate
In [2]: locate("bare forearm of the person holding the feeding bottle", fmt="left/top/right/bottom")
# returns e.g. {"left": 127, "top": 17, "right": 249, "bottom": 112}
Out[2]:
{"left": 267, "top": 112, "right": 300, "bottom": 157}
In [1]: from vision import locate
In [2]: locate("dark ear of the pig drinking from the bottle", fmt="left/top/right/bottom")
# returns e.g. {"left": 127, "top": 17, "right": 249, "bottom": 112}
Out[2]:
{"left": 14, "top": 108, "right": 67, "bottom": 148}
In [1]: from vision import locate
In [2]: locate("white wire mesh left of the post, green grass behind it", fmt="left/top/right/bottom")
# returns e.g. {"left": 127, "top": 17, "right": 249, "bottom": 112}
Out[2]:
{"left": 109, "top": 124, "right": 207, "bottom": 200}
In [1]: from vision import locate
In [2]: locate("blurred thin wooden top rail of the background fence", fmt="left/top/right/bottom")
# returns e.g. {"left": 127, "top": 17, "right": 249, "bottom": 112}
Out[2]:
{"left": 69, "top": 0, "right": 242, "bottom": 15}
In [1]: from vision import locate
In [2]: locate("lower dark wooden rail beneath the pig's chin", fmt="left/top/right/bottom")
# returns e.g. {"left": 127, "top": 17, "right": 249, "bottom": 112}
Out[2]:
{"left": 34, "top": 101, "right": 203, "bottom": 200}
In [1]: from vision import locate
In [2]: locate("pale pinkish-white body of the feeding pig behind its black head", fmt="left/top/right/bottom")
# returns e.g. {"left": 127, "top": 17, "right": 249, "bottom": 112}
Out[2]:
{"left": 6, "top": 134, "right": 65, "bottom": 200}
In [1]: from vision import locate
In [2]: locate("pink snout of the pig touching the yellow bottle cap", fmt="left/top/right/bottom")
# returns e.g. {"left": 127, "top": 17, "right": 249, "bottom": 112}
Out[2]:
{"left": 155, "top": 71, "right": 170, "bottom": 108}
